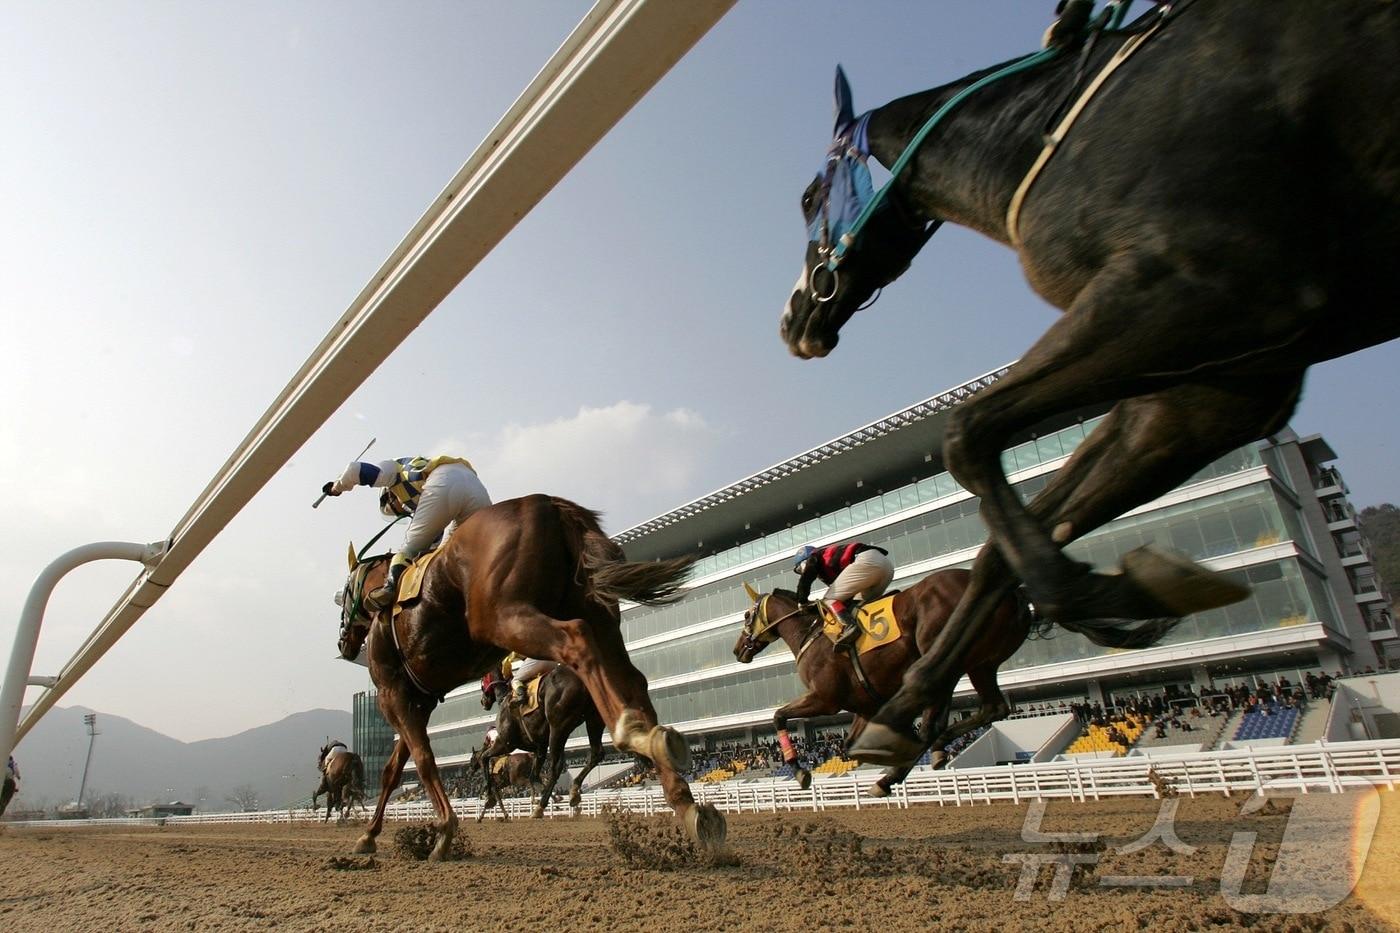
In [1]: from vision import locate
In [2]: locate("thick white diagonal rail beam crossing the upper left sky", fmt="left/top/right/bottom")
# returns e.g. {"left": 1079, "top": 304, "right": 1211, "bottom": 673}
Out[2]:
{"left": 8, "top": 0, "right": 735, "bottom": 756}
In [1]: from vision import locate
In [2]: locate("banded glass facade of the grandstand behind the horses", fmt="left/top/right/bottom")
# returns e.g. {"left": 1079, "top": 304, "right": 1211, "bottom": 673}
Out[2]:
{"left": 406, "top": 419, "right": 1341, "bottom": 763}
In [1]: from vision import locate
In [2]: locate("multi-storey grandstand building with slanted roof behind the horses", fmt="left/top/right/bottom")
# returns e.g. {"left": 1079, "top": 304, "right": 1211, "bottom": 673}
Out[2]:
{"left": 354, "top": 367, "right": 1400, "bottom": 769}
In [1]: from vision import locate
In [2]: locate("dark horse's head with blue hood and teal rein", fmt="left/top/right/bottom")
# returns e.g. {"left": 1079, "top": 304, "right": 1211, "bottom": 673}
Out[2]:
{"left": 778, "top": 66, "right": 939, "bottom": 360}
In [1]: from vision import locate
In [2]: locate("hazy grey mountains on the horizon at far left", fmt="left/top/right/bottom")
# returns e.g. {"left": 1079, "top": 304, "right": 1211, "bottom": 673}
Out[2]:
{"left": 14, "top": 706, "right": 351, "bottom": 811}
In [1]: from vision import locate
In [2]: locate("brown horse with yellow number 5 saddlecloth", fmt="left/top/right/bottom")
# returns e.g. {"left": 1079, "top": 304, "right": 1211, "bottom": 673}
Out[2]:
{"left": 734, "top": 569, "right": 1175, "bottom": 797}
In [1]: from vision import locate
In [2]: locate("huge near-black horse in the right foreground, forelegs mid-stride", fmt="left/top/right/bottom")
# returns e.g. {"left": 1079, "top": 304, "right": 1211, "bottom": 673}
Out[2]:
{"left": 781, "top": 0, "right": 1400, "bottom": 765}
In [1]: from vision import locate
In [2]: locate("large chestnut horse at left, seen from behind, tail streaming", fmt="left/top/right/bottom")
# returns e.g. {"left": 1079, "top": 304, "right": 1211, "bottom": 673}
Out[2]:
{"left": 340, "top": 496, "right": 725, "bottom": 859}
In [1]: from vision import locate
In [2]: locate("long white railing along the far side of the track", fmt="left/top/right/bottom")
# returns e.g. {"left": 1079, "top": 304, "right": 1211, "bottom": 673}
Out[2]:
{"left": 10, "top": 740, "right": 1400, "bottom": 828}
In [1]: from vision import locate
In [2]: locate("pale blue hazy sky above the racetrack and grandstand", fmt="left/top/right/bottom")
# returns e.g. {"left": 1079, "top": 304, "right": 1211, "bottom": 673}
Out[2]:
{"left": 0, "top": 0, "right": 1400, "bottom": 741}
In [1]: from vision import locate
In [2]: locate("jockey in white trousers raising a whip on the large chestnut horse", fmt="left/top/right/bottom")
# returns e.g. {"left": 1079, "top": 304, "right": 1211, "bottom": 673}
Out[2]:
{"left": 321, "top": 457, "right": 491, "bottom": 611}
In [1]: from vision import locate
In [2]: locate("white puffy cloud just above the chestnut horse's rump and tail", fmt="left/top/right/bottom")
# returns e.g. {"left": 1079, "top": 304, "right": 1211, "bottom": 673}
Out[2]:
{"left": 433, "top": 401, "right": 721, "bottom": 531}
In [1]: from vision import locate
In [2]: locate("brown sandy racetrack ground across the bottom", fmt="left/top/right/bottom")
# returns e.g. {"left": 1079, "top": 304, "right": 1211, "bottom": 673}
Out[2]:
{"left": 0, "top": 792, "right": 1400, "bottom": 933}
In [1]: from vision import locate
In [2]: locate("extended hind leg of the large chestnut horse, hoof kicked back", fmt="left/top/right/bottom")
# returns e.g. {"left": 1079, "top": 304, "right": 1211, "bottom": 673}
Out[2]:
{"left": 497, "top": 604, "right": 725, "bottom": 849}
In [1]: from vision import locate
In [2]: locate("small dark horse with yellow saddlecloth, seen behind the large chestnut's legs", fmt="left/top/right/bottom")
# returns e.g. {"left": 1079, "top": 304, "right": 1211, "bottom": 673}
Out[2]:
{"left": 477, "top": 664, "right": 603, "bottom": 821}
